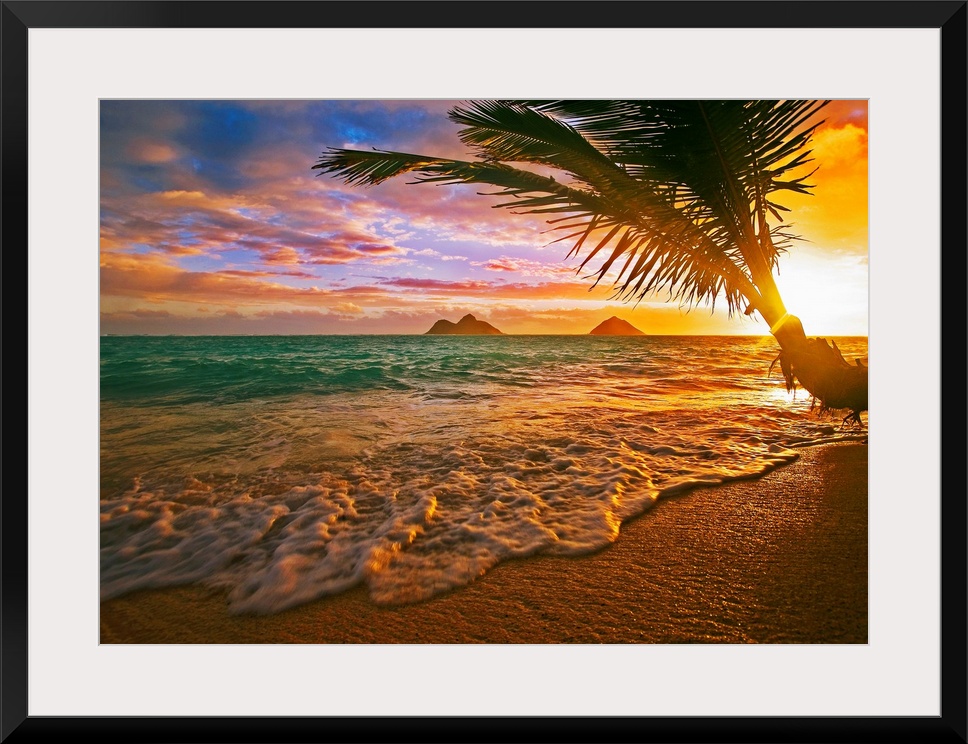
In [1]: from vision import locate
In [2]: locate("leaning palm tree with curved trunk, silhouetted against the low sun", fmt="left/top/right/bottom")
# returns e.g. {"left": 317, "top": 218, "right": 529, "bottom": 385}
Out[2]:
{"left": 312, "top": 100, "right": 867, "bottom": 423}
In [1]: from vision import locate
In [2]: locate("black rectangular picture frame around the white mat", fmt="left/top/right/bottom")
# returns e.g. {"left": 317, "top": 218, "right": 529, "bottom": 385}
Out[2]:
{"left": 0, "top": 0, "right": 968, "bottom": 744}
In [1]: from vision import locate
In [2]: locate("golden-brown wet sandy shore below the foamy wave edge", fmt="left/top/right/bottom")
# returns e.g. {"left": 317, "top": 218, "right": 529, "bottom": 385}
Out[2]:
{"left": 101, "top": 443, "right": 868, "bottom": 644}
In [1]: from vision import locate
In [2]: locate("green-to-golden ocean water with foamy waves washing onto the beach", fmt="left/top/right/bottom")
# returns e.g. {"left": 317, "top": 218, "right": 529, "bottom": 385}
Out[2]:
{"left": 100, "top": 335, "right": 867, "bottom": 614}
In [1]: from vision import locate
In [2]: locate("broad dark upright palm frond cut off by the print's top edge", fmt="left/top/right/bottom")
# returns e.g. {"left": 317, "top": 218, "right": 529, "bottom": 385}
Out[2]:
{"left": 516, "top": 101, "right": 826, "bottom": 284}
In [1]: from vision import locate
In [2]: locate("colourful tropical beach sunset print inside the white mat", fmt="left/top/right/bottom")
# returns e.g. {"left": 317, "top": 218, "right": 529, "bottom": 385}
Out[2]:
{"left": 99, "top": 99, "right": 869, "bottom": 644}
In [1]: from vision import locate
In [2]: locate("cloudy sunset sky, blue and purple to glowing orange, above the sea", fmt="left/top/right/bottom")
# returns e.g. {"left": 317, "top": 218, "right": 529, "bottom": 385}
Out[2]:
{"left": 100, "top": 100, "right": 868, "bottom": 336}
